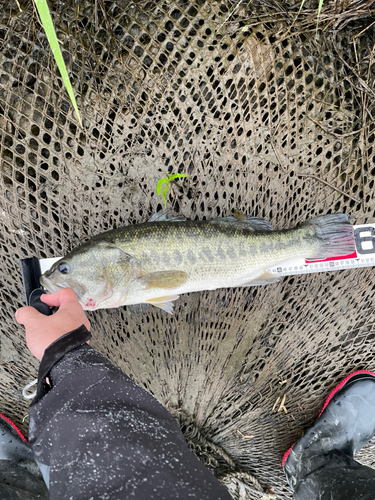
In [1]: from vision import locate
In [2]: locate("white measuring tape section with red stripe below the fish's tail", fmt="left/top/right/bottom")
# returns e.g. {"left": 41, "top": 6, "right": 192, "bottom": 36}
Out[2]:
{"left": 268, "top": 224, "right": 375, "bottom": 276}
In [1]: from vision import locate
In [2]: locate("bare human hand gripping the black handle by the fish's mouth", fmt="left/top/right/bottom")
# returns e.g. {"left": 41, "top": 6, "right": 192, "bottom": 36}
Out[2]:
{"left": 15, "top": 288, "right": 90, "bottom": 361}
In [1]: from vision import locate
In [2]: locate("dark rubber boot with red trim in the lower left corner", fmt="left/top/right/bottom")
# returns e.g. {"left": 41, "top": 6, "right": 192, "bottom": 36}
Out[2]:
{"left": 0, "top": 414, "right": 48, "bottom": 500}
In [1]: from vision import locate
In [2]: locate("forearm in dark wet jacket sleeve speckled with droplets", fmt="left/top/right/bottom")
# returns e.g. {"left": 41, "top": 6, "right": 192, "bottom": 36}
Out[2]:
{"left": 30, "top": 332, "right": 230, "bottom": 500}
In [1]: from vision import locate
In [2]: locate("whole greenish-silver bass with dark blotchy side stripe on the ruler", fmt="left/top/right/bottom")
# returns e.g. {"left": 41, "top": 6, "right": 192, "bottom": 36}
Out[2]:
{"left": 40, "top": 213, "right": 355, "bottom": 314}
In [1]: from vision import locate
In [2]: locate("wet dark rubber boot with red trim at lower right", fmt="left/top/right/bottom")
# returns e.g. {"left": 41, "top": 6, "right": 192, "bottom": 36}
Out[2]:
{"left": 283, "top": 371, "right": 375, "bottom": 500}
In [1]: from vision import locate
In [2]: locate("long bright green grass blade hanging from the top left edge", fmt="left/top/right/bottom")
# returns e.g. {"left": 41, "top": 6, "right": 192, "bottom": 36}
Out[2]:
{"left": 34, "top": 0, "right": 82, "bottom": 126}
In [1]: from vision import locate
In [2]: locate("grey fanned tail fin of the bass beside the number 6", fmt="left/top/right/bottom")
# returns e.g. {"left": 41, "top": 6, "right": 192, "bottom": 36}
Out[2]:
{"left": 302, "top": 214, "right": 355, "bottom": 260}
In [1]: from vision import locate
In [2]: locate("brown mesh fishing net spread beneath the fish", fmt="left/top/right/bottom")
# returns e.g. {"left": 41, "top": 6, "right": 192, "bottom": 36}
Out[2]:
{"left": 0, "top": 0, "right": 375, "bottom": 499}
